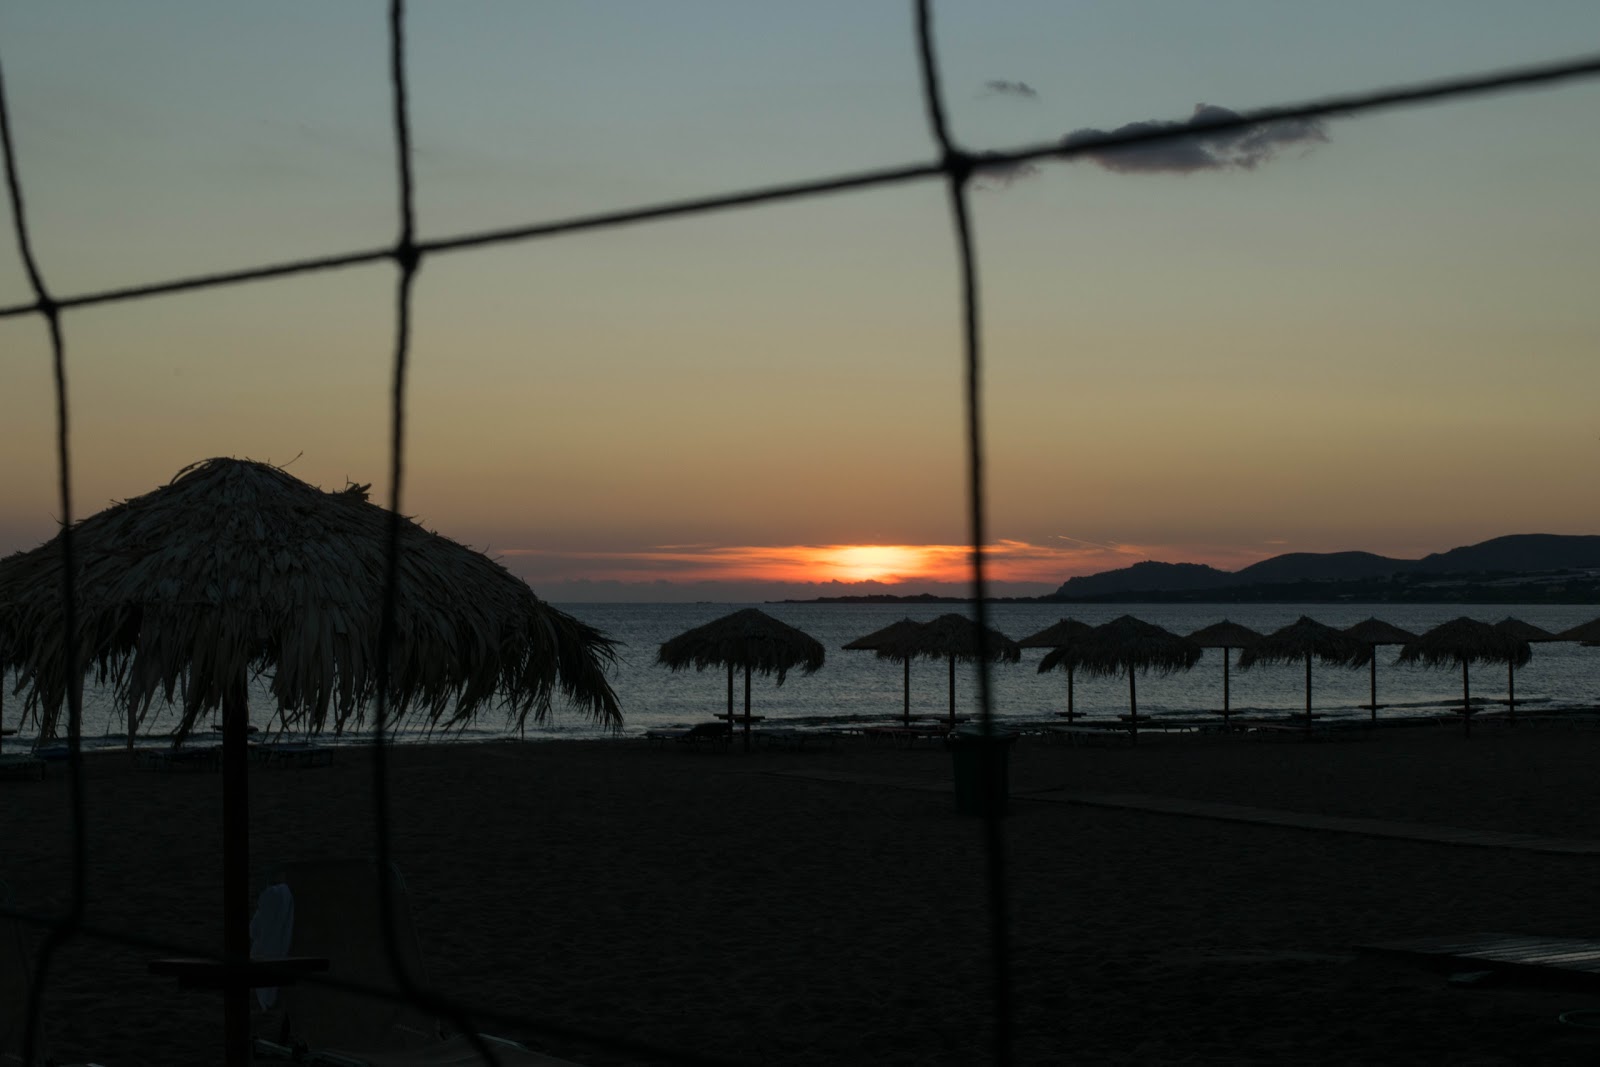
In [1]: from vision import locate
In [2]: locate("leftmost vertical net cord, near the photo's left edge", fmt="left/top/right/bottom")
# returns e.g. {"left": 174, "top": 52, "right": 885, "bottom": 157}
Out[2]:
{"left": 0, "top": 47, "right": 88, "bottom": 1064}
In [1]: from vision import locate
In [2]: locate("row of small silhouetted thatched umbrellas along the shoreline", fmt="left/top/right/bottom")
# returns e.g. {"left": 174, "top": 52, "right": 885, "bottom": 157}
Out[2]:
{"left": 658, "top": 608, "right": 1600, "bottom": 747}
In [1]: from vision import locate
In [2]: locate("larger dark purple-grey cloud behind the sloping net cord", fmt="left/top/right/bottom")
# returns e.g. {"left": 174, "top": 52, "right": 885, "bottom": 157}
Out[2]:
{"left": 1061, "top": 104, "right": 1328, "bottom": 174}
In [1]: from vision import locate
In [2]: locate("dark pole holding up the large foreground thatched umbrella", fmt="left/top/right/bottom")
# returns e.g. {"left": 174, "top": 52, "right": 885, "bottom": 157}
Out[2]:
{"left": 222, "top": 678, "right": 250, "bottom": 1064}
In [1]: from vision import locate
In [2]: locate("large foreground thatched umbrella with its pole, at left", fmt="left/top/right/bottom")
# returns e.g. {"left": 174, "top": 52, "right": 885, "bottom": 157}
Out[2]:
{"left": 0, "top": 459, "right": 621, "bottom": 1062}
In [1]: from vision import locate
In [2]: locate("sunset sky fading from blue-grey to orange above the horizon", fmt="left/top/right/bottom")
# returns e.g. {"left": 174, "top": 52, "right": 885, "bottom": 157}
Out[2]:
{"left": 0, "top": 0, "right": 1600, "bottom": 601}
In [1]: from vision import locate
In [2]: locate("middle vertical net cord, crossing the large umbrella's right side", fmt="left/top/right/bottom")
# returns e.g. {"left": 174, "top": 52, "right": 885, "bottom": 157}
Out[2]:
{"left": 373, "top": 0, "right": 499, "bottom": 1064}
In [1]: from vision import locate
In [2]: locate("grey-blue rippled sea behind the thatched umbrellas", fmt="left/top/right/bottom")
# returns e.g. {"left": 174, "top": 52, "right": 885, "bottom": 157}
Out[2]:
{"left": 12, "top": 603, "right": 1600, "bottom": 747}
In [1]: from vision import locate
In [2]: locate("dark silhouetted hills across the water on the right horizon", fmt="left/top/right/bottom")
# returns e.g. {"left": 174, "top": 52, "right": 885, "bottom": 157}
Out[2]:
{"left": 1053, "top": 534, "right": 1600, "bottom": 600}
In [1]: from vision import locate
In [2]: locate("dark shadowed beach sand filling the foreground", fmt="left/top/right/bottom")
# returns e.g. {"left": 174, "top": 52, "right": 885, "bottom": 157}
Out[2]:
{"left": 9, "top": 726, "right": 1600, "bottom": 1067}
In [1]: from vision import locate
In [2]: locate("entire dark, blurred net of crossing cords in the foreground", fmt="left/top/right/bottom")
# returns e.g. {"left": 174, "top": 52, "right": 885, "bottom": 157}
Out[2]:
{"left": 0, "top": 0, "right": 1600, "bottom": 1065}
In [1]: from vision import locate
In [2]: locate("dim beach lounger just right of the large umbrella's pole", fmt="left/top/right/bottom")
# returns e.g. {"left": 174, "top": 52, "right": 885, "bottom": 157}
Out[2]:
{"left": 256, "top": 861, "right": 585, "bottom": 1067}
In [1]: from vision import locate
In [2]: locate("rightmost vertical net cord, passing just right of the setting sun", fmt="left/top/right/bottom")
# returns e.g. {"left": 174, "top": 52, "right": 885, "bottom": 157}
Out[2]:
{"left": 915, "top": 0, "right": 1013, "bottom": 1067}
